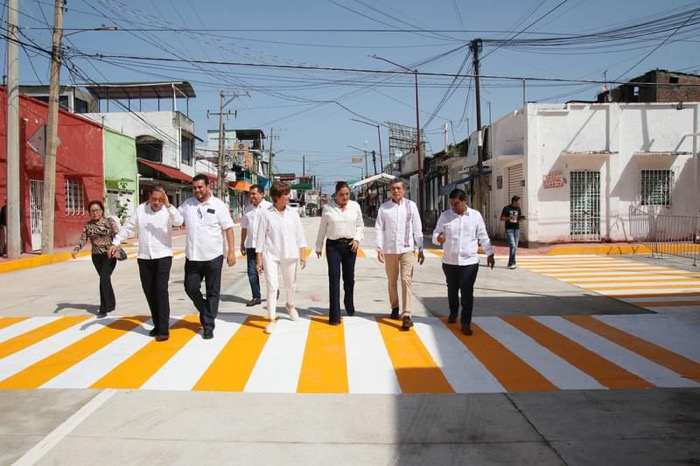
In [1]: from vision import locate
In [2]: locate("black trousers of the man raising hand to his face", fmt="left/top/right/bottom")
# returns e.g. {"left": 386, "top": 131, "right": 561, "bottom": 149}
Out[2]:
{"left": 138, "top": 256, "right": 173, "bottom": 336}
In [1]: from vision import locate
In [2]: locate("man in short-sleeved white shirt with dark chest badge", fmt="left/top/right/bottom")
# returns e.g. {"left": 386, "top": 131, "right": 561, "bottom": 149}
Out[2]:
{"left": 180, "top": 173, "right": 236, "bottom": 340}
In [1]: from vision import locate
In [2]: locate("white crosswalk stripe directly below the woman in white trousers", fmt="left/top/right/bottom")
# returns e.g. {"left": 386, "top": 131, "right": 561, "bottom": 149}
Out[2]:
{"left": 245, "top": 315, "right": 310, "bottom": 393}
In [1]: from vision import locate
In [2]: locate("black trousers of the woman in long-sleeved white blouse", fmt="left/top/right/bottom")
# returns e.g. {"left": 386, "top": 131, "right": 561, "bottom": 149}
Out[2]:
{"left": 326, "top": 239, "right": 357, "bottom": 323}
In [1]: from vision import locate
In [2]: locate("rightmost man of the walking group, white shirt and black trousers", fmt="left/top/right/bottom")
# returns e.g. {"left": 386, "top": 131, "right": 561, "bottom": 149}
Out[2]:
{"left": 433, "top": 189, "right": 495, "bottom": 335}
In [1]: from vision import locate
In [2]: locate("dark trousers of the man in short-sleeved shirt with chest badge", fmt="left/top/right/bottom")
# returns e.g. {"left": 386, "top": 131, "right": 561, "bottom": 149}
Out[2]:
{"left": 185, "top": 255, "right": 224, "bottom": 330}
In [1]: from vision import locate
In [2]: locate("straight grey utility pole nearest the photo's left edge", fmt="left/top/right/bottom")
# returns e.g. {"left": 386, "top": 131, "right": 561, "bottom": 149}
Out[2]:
{"left": 7, "top": 0, "right": 22, "bottom": 259}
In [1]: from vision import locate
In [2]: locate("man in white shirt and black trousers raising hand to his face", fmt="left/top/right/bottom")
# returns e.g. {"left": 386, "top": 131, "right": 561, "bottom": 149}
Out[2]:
{"left": 109, "top": 185, "right": 183, "bottom": 341}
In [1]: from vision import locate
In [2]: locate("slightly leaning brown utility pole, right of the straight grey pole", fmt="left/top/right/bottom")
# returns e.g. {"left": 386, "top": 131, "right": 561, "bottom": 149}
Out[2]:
{"left": 41, "top": 0, "right": 63, "bottom": 254}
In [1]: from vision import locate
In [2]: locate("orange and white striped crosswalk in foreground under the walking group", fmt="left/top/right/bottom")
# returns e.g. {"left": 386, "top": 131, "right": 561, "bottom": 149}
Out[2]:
{"left": 0, "top": 314, "right": 700, "bottom": 394}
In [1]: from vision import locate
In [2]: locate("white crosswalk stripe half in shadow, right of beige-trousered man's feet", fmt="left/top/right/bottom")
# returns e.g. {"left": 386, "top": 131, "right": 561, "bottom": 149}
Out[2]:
{"left": 413, "top": 317, "right": 506, "bottom": 393}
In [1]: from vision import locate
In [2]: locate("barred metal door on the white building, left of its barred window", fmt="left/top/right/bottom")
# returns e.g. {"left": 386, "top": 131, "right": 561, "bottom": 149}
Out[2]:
{"left": 569, "top": 170, "right": 600, "bottom": 241}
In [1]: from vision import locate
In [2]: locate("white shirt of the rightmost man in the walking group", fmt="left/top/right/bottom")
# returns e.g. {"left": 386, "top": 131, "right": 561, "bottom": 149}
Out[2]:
{"left": 433, "top": 207, "right": 493, "bottom": 265}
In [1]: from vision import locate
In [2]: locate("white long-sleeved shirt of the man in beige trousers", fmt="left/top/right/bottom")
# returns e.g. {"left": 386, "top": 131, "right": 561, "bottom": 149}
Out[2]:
{"left": 375, "top": 198, "right": 423, "bottom": 254}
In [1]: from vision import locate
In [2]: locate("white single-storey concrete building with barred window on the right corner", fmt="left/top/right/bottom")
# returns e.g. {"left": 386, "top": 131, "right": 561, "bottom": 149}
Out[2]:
{"left": 482, "top": 103, "right": 700, "bottom": 244}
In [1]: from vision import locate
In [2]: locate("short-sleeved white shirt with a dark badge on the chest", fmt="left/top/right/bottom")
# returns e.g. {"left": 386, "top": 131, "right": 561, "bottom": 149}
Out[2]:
{"left": 179, "top": 196, "right": 233, "bottom": 261}
